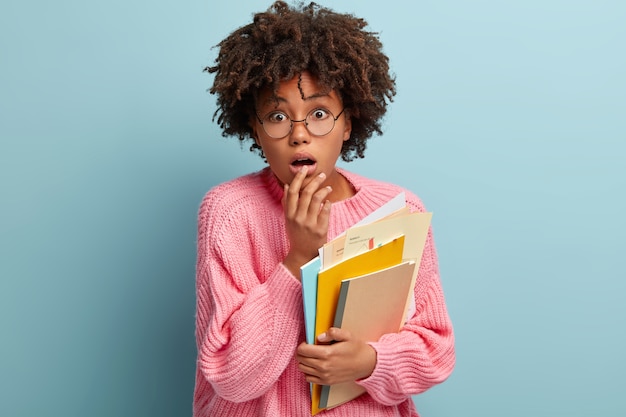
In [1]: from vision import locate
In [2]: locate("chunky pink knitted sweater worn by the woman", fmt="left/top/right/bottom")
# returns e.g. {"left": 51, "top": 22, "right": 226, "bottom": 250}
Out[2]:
{"left": 193, "top": 168, "right": 455, "bottom": 417}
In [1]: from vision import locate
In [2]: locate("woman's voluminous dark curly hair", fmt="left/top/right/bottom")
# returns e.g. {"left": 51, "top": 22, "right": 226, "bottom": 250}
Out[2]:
{"left": 204, "top": 1, "right": 396, "bottom": 162}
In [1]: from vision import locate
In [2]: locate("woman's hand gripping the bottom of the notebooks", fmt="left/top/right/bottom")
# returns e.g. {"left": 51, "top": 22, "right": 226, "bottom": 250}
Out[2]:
{"left": 296, "top": 327, "right": 376, "bottom": 385}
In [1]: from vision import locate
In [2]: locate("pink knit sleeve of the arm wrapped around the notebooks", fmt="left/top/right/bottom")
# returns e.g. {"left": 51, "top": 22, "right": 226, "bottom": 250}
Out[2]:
{"left": 358, "top": 193, "right": 455, "bottom": 405}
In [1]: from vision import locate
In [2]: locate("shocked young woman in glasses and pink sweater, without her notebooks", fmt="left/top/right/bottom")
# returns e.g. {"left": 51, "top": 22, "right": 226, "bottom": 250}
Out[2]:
{"left": 194, "top": 2, "right": 455, "bottom": 417}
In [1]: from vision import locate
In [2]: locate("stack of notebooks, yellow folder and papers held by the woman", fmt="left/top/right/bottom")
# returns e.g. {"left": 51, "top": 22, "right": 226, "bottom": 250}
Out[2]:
{"left": 300, "top": 193, "right": 432, "bottom": 415}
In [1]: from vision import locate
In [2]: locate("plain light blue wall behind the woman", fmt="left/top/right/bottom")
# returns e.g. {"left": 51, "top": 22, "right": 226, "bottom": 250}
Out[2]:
{"left": 0, "top": 0, "right": 626, "bottom": 417}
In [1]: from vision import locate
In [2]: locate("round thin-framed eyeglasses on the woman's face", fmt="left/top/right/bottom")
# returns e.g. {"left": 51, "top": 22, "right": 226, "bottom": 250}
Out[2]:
{"left": 256, "top": 107, "right": 345, "bottom": 139}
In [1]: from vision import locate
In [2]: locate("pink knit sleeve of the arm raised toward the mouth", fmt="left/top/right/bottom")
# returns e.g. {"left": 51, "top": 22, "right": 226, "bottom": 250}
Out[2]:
{"left": 196, "top": 190, "right": 302, "bottom": 402}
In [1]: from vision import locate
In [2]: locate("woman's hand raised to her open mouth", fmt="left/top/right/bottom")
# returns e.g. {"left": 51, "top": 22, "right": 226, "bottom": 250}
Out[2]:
{"left": 282, "top": 167, "right": 332, "bottom": 279}
